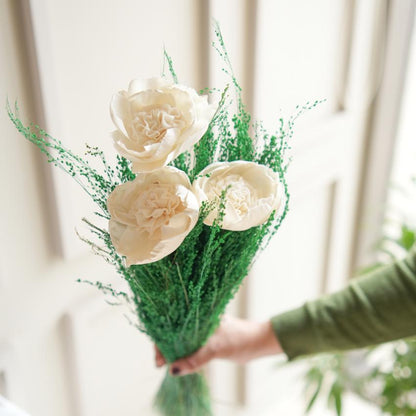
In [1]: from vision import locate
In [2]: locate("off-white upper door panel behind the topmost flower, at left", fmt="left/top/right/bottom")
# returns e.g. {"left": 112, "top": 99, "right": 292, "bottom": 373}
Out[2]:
{"left": 30, "top": 0, "right": 200, "bottom": 257}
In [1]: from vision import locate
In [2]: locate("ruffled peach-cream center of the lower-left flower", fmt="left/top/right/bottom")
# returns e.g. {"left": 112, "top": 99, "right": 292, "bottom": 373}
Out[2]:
{"left": 134, "top": 183, "right": 185, "bottom": 239}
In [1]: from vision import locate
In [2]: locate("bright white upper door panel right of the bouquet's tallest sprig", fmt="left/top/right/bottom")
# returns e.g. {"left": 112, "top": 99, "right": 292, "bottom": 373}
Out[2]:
{"left": 255, "top": 0, "right": 344, "bottom": 127}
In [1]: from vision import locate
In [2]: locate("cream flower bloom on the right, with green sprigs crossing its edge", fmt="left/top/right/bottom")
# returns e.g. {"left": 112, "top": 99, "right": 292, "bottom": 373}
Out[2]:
{"left": 193, "top": 160, "right": 283, "bottom": 231}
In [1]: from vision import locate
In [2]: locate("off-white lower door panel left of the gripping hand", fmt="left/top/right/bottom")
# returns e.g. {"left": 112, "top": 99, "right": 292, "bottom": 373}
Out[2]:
{"left": 65, "top": 296, "right": 164, "bottom": 416}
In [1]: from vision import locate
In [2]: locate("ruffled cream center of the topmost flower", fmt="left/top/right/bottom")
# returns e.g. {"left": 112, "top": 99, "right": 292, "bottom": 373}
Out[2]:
{"left": 132, "top": 104, "right": 185, "bottom": 146}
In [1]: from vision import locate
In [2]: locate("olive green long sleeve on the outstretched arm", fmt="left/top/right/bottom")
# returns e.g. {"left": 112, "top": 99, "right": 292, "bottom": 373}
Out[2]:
{"left": 271, "top": 247, "right": 416, "bottom": 360}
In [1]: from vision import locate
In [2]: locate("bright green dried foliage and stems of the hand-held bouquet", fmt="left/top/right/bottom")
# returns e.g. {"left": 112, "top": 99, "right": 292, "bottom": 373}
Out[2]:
{"left": 7, "top": 27, "right": 318, "bottom": 416}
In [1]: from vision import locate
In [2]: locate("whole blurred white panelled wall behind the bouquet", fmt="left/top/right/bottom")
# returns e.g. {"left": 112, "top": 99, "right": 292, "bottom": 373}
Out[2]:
{"left": 0, "top": 0, "right": 416, "bottom": 416}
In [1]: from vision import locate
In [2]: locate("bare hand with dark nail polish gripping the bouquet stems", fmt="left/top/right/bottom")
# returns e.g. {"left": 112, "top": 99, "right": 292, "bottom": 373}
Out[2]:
{"left": 155, "top": 315, "right": 283, "bottom": 376}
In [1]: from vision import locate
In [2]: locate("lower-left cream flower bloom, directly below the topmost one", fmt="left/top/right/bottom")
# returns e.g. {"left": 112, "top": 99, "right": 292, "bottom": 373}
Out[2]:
{"left": 107, "top": 167, "right": 199, "bottom": 266}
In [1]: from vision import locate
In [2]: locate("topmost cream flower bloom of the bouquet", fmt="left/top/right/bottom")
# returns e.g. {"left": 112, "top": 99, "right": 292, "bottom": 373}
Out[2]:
{"left": 110, "top": 78, "right": 215, "bottom": 172}
